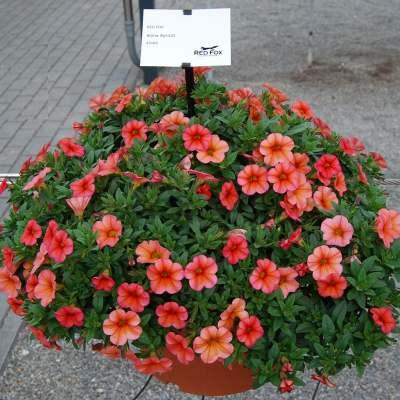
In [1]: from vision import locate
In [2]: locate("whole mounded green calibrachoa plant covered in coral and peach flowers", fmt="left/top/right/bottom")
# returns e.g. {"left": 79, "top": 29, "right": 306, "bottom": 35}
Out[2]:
{"left": 0, "top": 69, "right": 400, "bottom": 392}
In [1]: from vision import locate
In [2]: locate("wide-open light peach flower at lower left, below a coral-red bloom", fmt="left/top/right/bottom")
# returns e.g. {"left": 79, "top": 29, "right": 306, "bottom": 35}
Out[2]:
{"left": 103, "top": 309, "right": 142, "bottom": 346}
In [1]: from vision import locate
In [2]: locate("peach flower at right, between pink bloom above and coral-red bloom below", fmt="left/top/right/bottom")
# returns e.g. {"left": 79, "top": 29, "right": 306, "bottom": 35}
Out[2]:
{"left": 307, "top": 245, "right": 343, "bottom": 280}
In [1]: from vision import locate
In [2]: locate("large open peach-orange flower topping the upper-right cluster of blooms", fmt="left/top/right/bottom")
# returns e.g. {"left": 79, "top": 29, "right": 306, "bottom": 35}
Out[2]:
{"left": 259, "top": 133, "right": 294, "bottom": 166}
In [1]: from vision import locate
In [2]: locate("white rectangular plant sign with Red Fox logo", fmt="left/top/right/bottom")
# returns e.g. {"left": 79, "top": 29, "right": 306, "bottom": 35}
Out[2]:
{"left": 140, "top": 8, "right": 231, "bottom": 67}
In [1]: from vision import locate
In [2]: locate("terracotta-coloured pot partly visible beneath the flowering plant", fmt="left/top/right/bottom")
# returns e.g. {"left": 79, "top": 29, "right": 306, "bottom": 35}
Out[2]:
{"left": 156, "top": 354, "right": 253, "bottom": 396}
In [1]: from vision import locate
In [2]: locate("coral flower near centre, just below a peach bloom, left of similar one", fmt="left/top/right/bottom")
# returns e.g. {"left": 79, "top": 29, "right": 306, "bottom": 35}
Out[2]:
{"left": 147, "top": 259, "right": 185, "bottom": 294}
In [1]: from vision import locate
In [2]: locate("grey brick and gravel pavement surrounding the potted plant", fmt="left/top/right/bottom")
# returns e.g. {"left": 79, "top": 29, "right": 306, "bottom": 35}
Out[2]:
{"left": 0, "top": 0, "right": 400, "bottom": 400}
